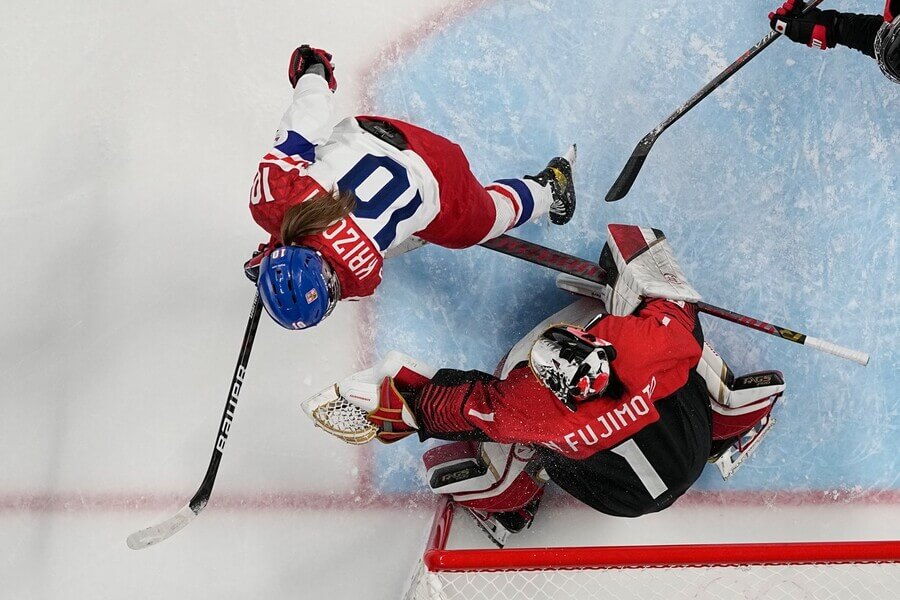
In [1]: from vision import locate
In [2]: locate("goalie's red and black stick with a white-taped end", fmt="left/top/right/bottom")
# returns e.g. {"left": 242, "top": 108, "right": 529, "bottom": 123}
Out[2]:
{"left": 481, "top": 235, "right": 869, "bottom": 365}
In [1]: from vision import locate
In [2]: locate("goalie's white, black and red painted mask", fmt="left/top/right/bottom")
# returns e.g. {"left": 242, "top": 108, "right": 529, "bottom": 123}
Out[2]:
{"left": 529, "top": 325, "right": 616, "bottom": 412}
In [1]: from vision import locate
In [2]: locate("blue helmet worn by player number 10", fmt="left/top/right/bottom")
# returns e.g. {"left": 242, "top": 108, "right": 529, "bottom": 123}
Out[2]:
{"left": 257, "top": 246, "right": 340, "bottom": 329}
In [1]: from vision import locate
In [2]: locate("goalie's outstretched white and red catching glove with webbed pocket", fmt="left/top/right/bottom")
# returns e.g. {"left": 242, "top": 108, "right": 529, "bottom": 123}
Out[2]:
{"left": 302, "top": 352, "right": 435, "bottom": 444}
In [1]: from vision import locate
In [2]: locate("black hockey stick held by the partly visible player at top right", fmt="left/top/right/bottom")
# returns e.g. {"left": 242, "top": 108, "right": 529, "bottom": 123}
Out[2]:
{"left": 606, "top": 0, "right": 823, "bottom": 202}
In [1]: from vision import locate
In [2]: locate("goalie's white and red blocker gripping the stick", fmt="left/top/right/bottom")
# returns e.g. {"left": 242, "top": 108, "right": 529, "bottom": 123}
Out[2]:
{"left": 600, "top": 224, "right": 700, "bottom": 316}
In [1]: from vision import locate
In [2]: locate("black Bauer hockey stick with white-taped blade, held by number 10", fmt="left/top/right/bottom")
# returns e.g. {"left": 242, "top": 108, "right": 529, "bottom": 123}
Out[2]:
{"left": 126, "top": 292, "right": 262, "bottom": 550}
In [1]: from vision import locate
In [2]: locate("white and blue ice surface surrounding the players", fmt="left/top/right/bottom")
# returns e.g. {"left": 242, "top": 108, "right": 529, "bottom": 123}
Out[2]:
{"left": 0, "top": 0, "right": 900, "bottom": 600}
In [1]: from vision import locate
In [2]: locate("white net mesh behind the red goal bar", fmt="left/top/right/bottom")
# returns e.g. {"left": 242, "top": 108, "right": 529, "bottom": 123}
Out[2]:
{"left": 405, "top": 563, "right": 900, "bottom": 600}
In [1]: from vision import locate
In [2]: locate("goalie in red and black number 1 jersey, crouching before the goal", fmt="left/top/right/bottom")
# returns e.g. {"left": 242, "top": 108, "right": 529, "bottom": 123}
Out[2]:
{"left": 304, "top": 225, "right": 784, "bottom": 545}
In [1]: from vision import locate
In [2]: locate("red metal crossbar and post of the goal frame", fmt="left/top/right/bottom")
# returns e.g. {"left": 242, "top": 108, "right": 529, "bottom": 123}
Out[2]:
{"left": 422, "top": 501, "right": 900, "bottom": 573}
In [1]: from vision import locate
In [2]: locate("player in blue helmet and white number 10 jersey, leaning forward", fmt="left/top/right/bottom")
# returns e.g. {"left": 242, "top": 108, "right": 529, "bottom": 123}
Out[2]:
{"left": 245, "top": 45, "right": 575, "bottom": 329}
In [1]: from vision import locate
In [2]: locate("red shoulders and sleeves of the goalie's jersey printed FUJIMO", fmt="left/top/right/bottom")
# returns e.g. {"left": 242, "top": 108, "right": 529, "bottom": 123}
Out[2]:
{"left": 415, "top": 300, "right": 701, "bottom": 458}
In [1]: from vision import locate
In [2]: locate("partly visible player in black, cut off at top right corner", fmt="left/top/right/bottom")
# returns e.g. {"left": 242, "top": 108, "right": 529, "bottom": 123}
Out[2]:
{"left": 769, "top": 0, "right": 900, "bottom": 83}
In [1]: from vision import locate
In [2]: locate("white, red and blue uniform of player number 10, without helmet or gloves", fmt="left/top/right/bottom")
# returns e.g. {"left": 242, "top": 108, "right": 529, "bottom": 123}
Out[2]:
{"left": 250, "top": 74, "right": 551, "bottom": 298}
